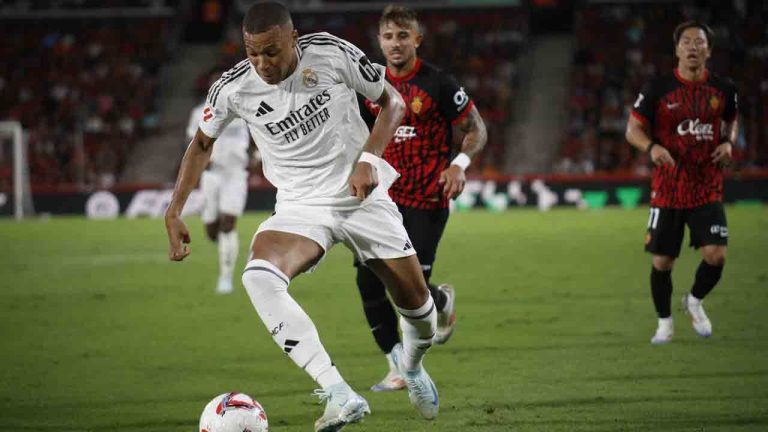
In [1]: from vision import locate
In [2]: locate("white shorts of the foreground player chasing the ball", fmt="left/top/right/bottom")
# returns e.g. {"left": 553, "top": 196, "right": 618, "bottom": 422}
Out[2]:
{"left": 254, "top": 196, "right": 416, "bottom": 272}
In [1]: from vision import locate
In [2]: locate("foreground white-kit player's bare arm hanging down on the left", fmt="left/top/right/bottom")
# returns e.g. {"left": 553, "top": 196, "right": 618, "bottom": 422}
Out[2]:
{"left": 165, "top": 129, "right": 215, "bottom": 261}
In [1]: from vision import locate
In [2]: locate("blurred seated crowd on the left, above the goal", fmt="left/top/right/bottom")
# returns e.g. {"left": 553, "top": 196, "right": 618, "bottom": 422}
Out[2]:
{"left": 0, "top": 18, "right": 169, "bottom": 187}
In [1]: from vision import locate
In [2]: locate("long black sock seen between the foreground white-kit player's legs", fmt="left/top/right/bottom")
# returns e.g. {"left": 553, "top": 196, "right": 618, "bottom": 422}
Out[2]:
{"left": 357, "top": 266, "right": 400, "bottom": 353}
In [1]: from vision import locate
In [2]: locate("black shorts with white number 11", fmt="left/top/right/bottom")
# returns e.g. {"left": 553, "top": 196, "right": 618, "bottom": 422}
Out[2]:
{"left": 645, "top": 202, "right": 728, "bottom": 258}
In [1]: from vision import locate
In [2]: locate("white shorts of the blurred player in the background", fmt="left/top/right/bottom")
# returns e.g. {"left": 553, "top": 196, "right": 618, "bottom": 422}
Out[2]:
{"left": 200, "top": 169, "right": 248, "bottom": 224}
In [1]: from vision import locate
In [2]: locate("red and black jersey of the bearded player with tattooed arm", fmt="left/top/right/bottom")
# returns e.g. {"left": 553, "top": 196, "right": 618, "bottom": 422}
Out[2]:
{"left": 360, "top": 59, "right": 474, "bottom": 209}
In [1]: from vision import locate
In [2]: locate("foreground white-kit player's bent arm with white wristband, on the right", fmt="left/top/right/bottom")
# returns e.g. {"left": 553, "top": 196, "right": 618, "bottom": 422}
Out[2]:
{"left": 349, "top": 81, "right": 405, "bottom": 201}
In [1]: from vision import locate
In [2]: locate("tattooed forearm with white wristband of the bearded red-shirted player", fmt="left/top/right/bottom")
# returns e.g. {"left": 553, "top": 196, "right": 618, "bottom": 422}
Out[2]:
{"left": 439, "top": 105, "right": 488, "bottom": 199}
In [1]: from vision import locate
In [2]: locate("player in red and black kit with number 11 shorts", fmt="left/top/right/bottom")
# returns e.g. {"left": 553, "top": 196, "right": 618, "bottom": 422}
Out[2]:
{"left": 627, "top": 21, "right": 738, "bottom": 344}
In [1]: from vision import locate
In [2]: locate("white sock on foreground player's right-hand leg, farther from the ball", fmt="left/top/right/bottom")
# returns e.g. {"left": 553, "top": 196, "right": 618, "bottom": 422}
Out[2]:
{"left": 397, "top": 296, "right": 437, "bottom": 370}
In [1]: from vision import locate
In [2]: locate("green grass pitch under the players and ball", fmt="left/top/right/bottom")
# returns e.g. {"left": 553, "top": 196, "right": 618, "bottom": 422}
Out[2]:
{"left": 0, "top": 207, "right": 768, "bottom": 432}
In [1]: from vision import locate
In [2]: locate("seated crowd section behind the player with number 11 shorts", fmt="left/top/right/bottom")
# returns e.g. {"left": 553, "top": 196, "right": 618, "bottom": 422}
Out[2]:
{"left": 555, "top": 2, "right": 768, "bottom": 175}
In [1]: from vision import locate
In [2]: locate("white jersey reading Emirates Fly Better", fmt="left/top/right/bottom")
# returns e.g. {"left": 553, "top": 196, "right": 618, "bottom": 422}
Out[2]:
{"left": 200, "top": 33, "right": 391, "bottom": 205}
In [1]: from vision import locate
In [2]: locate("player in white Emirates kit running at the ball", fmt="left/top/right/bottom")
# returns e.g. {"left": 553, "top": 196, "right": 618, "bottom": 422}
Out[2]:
{"left": 165, "top": 2, "right": 439, "bottom": 431}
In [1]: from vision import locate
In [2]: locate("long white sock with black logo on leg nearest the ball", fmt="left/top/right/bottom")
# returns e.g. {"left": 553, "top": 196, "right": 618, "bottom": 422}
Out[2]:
{"left": 243, "top": 259, "right": 344, "bottom": 389}
